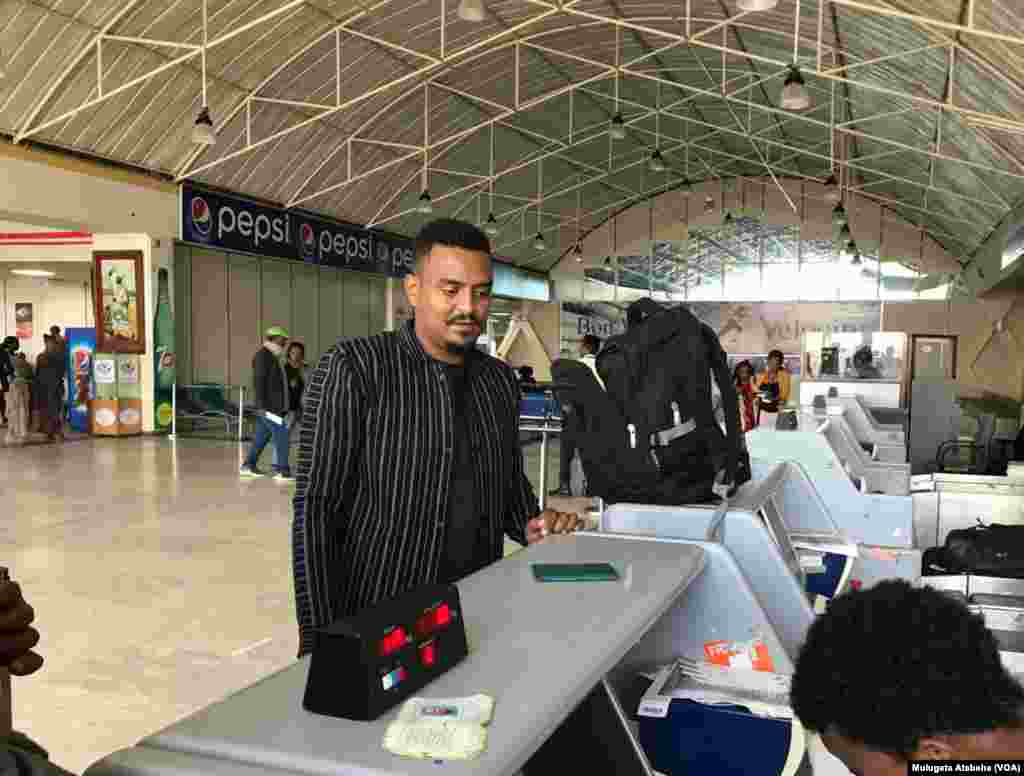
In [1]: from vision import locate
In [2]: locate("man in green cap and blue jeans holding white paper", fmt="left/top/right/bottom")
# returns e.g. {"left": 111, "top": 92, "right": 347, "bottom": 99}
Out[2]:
{"left": 241, "top": 326, "right": 293, "bottom": 482}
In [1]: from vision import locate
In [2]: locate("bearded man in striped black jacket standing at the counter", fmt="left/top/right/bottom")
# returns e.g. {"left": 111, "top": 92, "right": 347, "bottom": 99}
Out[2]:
{"left": 292, "top": 219, "right": 579, "bottom": 656}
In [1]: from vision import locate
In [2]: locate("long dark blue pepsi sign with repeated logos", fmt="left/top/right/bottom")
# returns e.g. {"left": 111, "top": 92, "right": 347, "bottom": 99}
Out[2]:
{"left": 180, "top": 183, "right": 414, "bottom": 277}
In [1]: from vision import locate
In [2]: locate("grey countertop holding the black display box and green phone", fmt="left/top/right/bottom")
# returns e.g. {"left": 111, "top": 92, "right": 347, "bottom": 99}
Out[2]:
{"left": 86, "top": 533, "right": 705, "bottom": 776}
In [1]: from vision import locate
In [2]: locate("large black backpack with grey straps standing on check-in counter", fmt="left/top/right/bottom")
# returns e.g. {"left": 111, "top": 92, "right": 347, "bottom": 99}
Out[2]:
{"left": 552, "top": 299, "right": 751, "bottom": 506}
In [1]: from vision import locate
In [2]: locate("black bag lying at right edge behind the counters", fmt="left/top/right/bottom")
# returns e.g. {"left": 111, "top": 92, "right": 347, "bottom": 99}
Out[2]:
{"left": 922, "top": 523, "right": 1024, "bottom": 579}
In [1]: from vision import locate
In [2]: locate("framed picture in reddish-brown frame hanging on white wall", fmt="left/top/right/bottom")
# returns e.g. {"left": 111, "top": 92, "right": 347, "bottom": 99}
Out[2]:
{"left": 92, "top": 251, "right": 145, "bottom": 353}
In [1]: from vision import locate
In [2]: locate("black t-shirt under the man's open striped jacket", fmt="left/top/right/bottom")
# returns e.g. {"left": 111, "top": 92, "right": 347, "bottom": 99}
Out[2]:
{"left": 439, "top": 363, "right": 494, "bottom": 583}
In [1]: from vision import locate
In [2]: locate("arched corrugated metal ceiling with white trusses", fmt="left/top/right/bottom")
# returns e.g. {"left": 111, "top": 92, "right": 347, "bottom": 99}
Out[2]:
{"left": 0, "top": 0, "right": 1024, "bottom": 269}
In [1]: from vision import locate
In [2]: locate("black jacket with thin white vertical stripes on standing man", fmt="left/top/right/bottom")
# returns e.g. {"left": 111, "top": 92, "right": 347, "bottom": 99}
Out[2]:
{"left": 292, "top": 320, "right": 540, "bottom": 656}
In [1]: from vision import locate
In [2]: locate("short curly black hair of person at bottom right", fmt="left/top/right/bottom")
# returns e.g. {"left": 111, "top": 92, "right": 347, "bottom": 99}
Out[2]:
{"left": 792, "top": 580, "right": 1024, "bottom": 757}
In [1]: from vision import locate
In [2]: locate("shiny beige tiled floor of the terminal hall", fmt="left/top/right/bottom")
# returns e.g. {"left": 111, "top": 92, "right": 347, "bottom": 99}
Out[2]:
{"left": 0, "top": 438, "right": 574, "bottom": 773}
